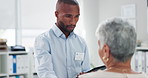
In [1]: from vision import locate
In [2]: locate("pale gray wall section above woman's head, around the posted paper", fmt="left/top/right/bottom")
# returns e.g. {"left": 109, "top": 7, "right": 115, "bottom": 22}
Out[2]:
{"left": 99, "top": 0, "right": 148, "bottom": 41}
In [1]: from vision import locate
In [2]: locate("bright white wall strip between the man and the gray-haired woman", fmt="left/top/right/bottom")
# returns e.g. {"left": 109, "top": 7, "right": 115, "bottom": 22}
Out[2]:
{"left": 83, "top": 0, "right": 104, "bottom": 66}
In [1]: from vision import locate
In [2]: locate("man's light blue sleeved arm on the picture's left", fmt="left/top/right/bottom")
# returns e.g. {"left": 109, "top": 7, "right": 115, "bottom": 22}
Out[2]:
{"left": 34, "top": 36, "right": 57, "bottom": 78}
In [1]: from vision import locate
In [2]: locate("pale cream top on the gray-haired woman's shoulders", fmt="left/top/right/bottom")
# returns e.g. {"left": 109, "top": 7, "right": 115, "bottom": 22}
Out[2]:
{"left": 78, "top": 70, "right": 148, "bottom": 78}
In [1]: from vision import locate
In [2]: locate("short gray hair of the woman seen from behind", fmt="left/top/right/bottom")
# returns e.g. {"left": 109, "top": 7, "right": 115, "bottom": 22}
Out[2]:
{"left": 96, "top": 17, "right": 137, "bottom": 62}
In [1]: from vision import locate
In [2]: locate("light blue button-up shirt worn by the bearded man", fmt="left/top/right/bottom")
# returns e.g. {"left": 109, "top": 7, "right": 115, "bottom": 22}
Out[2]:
{"left": 34, "top": 25, "right": 90, "bottom": 78}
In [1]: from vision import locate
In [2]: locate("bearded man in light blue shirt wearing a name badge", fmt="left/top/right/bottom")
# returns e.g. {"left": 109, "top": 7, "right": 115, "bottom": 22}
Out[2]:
{"left": 34, "top": 0, "right": 90, "bottom": 78}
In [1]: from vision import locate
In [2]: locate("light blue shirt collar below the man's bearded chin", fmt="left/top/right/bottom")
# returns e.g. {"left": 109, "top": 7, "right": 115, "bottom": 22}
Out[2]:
{"left": 52, "top": 24, "right": 76, "bottom": 39}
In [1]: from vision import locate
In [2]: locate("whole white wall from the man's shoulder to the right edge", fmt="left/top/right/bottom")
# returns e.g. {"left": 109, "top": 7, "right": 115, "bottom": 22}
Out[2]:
{"left": 83, "top": 0, "right": 148, "bottom": 66}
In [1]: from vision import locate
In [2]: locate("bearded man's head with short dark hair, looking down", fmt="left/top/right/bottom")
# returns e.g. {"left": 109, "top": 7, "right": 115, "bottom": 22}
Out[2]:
{"left": 55, "top": 0, "right": 80, "bottom": 34}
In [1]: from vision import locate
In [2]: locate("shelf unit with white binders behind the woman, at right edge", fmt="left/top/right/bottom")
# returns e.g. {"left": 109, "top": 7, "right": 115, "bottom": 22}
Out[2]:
{"left": 131, "top": 47, "right": 148, "bottom": 74}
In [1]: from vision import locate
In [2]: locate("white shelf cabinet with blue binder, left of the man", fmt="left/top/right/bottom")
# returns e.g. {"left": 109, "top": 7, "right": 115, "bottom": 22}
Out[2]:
{"left": 0, "top": 51, "right": 31, "bottom": 78}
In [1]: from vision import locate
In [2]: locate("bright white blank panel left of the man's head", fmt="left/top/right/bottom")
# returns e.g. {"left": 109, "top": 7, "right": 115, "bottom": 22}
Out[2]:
{"left": 21, "top": 0, "right": 57, "bottom": 29}
